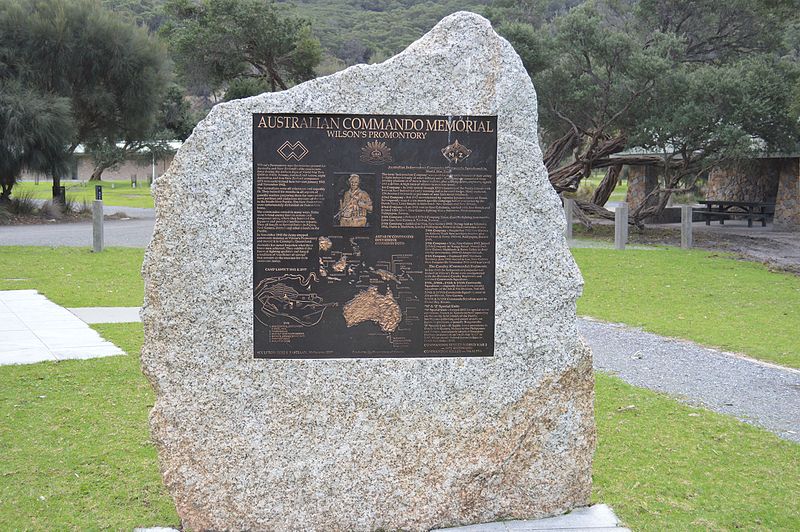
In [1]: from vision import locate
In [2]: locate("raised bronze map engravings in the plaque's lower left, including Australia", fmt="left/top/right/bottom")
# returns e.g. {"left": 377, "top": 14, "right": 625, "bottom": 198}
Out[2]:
{"left": 255, "top": 234, "right": 424, "bottom": 346}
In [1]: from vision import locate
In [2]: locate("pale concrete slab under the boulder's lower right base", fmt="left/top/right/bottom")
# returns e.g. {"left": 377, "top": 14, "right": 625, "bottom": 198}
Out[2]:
{"left": 434, "top": 504, "right": 628, "bottom": 532}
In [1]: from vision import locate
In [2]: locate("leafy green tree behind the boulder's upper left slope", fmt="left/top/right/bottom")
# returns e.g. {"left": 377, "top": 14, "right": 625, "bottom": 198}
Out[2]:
{"left": 161, "top": 0, "right": 322, "bottom": 92}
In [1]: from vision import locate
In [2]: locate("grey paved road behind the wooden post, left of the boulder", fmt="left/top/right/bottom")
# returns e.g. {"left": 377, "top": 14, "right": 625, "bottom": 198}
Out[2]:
{"left": 0, "top": 207, "right": 155, "bottom": 248}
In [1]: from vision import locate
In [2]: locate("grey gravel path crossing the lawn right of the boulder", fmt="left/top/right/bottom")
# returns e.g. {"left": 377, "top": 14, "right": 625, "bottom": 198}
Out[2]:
{"left": 578, "top": 318, "right": 800, "bottom": 443}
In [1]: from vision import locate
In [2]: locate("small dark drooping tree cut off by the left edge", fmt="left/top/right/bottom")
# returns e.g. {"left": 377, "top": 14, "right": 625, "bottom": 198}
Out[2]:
{"left": 0, "top": 82, "right": 73, "bottom": 203}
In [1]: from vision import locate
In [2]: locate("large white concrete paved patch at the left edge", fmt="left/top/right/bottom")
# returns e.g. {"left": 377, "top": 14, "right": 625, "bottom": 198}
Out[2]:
{"left": 0, "top": 290, "right": 125, "bottom": 365}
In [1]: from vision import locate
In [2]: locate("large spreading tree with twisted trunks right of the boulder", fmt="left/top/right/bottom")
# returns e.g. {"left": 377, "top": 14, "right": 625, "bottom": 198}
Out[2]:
{"left": 501, "top": 0, "right": 798, "bottom": 224}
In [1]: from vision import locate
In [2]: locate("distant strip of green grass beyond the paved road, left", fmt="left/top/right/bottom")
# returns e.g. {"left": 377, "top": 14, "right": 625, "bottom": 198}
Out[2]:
{"left": 11, "top": 180, "right": 153, "bottom": 209}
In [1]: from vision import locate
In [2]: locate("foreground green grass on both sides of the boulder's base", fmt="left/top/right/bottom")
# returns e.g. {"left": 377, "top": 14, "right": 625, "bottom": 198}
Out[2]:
{"left": 0, "top": 324, "right": 800, "bottom": 530}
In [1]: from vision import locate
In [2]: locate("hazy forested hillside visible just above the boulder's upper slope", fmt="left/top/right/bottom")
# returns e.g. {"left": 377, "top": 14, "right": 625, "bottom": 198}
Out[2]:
{"left": 278, "top": 0, "right": 492, "bottom": 65}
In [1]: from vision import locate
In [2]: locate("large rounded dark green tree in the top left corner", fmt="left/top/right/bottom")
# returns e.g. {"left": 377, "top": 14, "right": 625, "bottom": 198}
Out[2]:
{"left": 0, "top": 0, "right": 169, "bottom": 185}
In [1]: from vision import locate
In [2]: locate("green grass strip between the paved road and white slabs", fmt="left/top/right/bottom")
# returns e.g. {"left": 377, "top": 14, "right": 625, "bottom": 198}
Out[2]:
{"left": 0, "top": 246, "right": 144, "bottom": 307}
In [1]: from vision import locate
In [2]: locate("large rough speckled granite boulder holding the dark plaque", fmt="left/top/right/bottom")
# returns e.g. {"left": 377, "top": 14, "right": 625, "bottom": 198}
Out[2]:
{"left": 142, "top": 12, "right": 595, "bottom": 530}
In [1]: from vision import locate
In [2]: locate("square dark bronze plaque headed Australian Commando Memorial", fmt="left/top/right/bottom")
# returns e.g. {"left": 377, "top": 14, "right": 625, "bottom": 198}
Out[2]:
{"left": 253, "top": 113, "right": 497, "bottom": 358}
